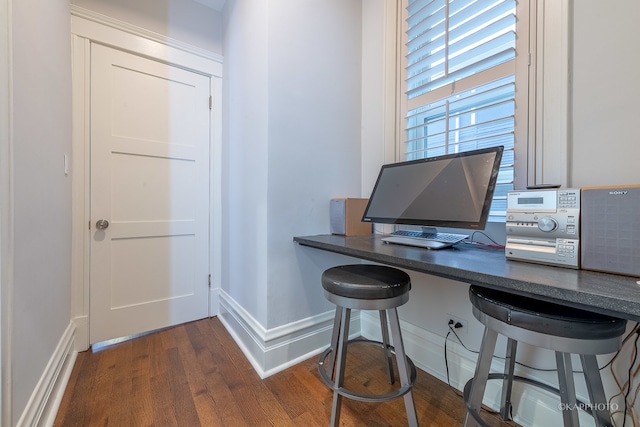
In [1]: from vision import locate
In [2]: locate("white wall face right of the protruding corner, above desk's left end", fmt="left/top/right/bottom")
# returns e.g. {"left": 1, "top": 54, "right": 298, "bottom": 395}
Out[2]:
{"left": 265, "top": 0, "right": 362, "bottom": 328}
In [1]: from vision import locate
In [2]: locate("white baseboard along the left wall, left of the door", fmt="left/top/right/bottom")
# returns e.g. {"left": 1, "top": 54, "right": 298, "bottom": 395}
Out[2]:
{"left": 17, "top": 321, "right": 78, "bottom": 427}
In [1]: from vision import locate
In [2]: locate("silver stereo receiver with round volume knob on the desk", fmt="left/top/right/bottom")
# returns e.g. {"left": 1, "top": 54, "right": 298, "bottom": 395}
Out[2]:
{"left": 505, "top": 188, "right": 580, "bottom": 269}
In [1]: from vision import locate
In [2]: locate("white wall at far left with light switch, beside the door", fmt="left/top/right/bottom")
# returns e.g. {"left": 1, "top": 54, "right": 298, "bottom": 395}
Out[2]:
{"left": 10, "top": 0, "right": 71, "bottom": 424}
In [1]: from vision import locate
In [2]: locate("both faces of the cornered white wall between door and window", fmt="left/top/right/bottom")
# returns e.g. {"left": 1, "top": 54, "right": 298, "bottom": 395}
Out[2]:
{"left": 222, "top": 0, "right": 361, "bottom": 330}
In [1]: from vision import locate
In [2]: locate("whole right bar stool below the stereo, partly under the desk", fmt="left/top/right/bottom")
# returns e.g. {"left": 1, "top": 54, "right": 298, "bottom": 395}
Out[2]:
{"left": 464, "top": 286, "right": 627, "bottom": 427}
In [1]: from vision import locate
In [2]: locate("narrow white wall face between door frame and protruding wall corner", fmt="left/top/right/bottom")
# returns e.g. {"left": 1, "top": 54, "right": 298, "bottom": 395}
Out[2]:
{"left": 222, "top": 1, "right": 269, "bottom": 327}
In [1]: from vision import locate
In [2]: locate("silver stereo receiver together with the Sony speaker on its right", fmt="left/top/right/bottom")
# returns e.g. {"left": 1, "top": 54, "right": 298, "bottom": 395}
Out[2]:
{"left": 505, "top": 185, "right": 640, "bottom": 276}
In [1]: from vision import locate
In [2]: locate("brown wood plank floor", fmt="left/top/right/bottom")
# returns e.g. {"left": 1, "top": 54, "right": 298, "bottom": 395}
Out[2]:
{"left": 54, "top": 317, "right": 512, "bottom": 427}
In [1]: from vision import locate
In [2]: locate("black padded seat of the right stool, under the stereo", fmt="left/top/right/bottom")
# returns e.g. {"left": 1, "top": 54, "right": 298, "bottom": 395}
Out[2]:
{"left": 469, "top": 286, "right": 627, "bottom": 340}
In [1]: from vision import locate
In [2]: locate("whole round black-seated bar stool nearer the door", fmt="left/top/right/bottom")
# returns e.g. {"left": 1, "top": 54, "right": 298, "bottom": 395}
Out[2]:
{"left": 318, "top": 264, "right": 418, "bottom": 426}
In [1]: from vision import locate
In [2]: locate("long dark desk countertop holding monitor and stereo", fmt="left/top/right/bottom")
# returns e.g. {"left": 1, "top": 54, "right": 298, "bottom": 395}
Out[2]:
{"left": 293, "top": 235, "right": 640, "bottom": 321}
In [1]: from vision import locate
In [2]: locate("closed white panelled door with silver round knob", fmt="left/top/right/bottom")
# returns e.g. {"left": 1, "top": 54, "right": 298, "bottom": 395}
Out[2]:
{"left": 89, "top": 44, "right": 210, "bottom": 343}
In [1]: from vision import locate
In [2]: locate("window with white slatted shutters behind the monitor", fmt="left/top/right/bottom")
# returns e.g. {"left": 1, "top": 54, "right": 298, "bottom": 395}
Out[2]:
{"left": 400, "top": 0, "right": 528, "bottom": 221}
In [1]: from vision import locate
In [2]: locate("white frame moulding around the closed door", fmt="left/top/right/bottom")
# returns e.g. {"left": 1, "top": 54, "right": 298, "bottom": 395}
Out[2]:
{"left": 71, "top": 5, "right": 223, "bottom": 351}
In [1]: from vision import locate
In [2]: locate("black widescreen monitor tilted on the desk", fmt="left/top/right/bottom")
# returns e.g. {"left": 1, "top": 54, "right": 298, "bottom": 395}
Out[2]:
{"left": 362, "top": 146, "right": 504, "bottom": 230}
